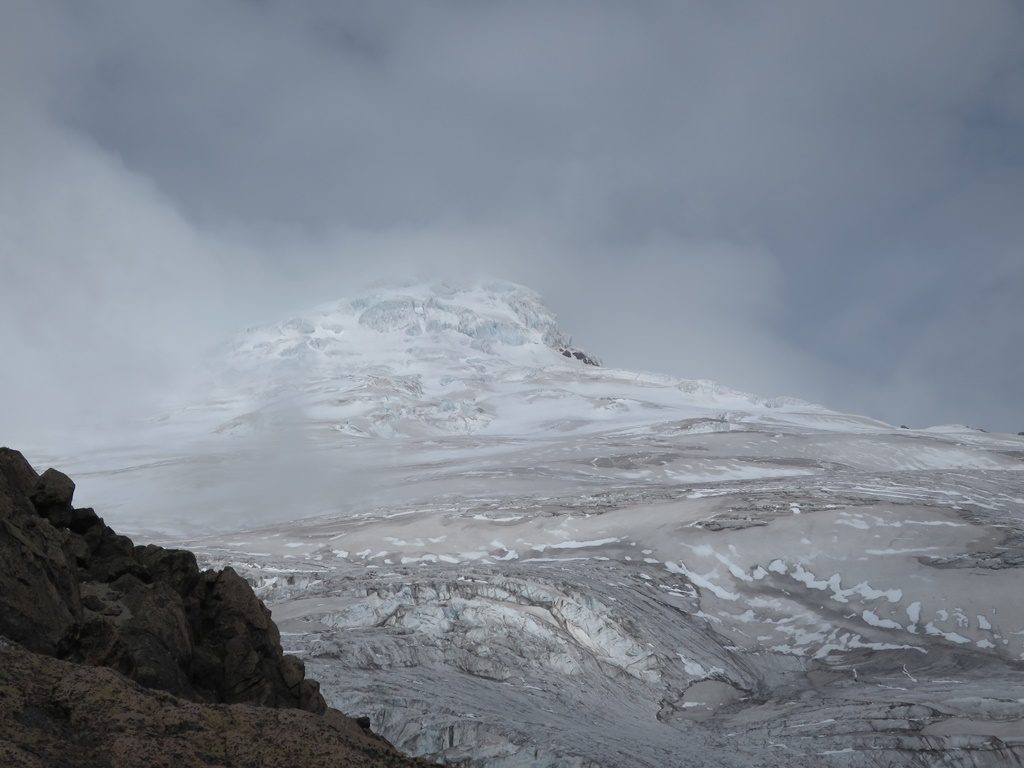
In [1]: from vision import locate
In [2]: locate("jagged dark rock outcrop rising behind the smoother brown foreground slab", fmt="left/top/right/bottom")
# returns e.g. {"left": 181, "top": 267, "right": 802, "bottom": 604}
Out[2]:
{"left": 0, "top": 449, "right": 327, "bottom": 714}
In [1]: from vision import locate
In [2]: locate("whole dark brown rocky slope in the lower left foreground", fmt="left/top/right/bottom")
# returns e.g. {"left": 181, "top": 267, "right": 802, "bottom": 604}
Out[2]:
{"left": 0, "top": 449, "right": 425, "bottom": 768}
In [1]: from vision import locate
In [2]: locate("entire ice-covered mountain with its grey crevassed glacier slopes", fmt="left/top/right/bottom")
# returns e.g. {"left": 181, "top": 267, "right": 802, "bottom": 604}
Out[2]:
{"left": 36, "top": 284, "right": 1024, "bottom": 767}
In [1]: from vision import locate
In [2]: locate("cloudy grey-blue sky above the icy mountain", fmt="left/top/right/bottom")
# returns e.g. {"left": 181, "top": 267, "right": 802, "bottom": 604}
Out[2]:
{"left": 0, "top": 0, "right": 1024, "bottom": 442}
